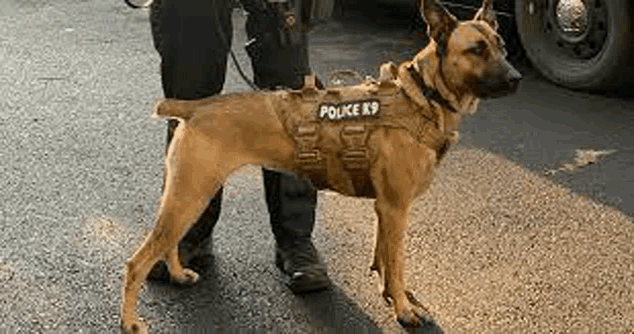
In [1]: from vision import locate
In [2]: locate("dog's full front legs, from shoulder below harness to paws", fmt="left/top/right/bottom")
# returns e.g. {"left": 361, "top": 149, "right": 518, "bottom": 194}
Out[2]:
{"left": 369, "top": 128, "right": 432, "bottom": 327}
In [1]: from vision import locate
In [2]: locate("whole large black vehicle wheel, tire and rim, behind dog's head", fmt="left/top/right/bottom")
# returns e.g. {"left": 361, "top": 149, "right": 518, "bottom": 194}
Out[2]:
{"left": 515, "top": 0, "right": 634, "bottom": 91}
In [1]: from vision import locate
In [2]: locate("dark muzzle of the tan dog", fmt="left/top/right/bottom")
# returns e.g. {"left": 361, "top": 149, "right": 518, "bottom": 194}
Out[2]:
{"left": 475, "top": 60, "right": 522, "bottom": 99}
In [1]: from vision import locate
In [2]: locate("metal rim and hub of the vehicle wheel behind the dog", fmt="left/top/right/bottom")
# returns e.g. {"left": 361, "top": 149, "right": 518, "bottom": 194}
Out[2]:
{"left": 528, "top": 0, "right": 608, "bottom": 60}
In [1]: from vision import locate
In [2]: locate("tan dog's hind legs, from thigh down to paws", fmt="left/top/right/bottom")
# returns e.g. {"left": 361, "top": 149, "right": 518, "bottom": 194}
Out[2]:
{"left": 121, "top": 128, "right": 224, "bottom": 333}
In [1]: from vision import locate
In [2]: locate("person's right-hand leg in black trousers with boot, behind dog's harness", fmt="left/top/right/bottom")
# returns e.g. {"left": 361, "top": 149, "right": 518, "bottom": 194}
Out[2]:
{"left": 247, "top": 3, "right": 330, "bottom": 293}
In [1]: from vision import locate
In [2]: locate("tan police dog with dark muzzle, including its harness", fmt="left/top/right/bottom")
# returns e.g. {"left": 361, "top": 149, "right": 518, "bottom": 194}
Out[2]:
{"left": 121, "top": 0, "right": 521, "bottom": 333}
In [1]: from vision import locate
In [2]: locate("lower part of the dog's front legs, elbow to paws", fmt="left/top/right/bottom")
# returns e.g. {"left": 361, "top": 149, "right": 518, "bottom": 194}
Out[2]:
{"left": 373, "top": 198, "right": 433, "bottom": 327}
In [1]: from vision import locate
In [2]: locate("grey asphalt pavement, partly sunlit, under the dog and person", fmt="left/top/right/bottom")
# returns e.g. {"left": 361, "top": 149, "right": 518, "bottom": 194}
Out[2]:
{"left": 0, "top": 0, "right": 634, "bottom": 333}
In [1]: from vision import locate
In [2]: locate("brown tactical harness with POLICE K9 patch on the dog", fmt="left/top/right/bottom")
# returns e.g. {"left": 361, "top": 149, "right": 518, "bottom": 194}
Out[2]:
{"left": 276, "top": 68, "right": 455, "bottom": 198}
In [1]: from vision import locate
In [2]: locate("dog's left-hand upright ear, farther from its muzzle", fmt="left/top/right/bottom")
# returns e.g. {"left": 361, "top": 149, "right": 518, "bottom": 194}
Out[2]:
{"left": 420, "top": 0, "right": 458, "bottom": 54}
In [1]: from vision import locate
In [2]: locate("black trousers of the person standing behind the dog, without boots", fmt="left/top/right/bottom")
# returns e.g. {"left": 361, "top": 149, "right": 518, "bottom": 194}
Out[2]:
{"left": 150, "top": 0, "right": 316, "bottom": 251}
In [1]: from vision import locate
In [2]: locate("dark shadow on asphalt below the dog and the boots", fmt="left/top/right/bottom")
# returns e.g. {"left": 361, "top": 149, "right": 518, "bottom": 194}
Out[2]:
{"left": 146, "top": 255, "right": 390, "bottom": 334}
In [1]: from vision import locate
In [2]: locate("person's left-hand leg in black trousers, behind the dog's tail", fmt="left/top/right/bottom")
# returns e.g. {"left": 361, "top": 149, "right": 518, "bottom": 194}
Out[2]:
{"left": 148, "top": 0, "right": 232, "bottom": 281}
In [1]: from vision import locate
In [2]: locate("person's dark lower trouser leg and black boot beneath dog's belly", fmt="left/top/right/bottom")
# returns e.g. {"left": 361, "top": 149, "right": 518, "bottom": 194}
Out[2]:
{"left": 263, "top": 169, "right": 330, "bottom": 294}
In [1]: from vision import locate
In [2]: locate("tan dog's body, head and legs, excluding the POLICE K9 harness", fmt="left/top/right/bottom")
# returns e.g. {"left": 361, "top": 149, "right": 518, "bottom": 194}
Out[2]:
{"left": 121, "top": 0, "right": 521, "bottom": 333}
